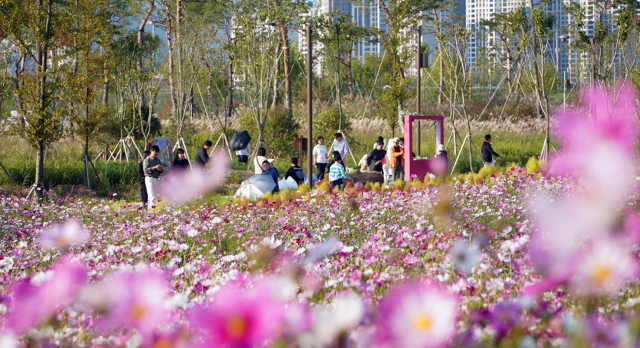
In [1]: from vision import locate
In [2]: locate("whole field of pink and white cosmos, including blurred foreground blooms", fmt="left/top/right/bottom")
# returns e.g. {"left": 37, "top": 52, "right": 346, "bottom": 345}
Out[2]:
{"left": 0, "top": 88, "right": 640, "bottom": 347}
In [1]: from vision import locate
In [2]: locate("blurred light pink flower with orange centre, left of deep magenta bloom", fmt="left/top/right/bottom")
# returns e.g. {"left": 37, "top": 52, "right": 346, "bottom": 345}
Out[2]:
{"left": 91, "top": 269, "right": 168, "bottom": 341}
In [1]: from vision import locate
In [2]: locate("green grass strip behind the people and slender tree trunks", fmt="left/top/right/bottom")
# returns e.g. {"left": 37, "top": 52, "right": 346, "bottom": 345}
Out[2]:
{"left": 0, "top": 129, "right": 544, "bottom": 190}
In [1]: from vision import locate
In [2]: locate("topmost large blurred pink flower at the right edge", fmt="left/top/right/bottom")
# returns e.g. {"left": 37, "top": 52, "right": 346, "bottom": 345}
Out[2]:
{"left": 551, "top": 84, "right": 638, "bottom": 207}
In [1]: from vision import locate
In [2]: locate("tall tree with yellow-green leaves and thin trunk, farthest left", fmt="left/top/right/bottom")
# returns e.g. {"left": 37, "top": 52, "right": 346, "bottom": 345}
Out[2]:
{"left": 0, "top": 0, "right": 73, "bottom": 198}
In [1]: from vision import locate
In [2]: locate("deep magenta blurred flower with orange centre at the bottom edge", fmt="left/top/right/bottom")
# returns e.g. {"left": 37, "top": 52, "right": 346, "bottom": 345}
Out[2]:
{"left": 189, "top": 284, "right": 285, "bottom": 348}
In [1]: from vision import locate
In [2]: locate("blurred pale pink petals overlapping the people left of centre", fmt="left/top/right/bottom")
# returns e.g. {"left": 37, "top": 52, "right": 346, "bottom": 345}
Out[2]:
{"left": 160, "top": 151, "right": 230, "bottom": 204}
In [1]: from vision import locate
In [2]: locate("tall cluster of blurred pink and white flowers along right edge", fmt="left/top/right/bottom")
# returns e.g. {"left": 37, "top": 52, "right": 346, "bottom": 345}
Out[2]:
{"left": 525, "top": 82, "right": 637, "bottom": 295}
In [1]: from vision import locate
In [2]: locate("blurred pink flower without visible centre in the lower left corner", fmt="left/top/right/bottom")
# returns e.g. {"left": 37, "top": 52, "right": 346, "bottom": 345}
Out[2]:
{"left": 5, "top": 259, "right": 87, "bottom": 334}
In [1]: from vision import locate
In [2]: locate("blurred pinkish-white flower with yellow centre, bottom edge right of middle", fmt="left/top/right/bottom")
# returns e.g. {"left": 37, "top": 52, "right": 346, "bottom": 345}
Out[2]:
{"left": 376, "top": 283, "right": 458, "bottom": 348}
